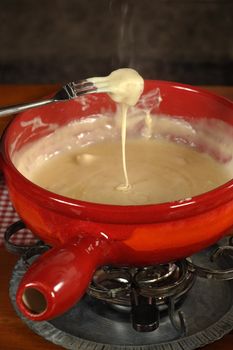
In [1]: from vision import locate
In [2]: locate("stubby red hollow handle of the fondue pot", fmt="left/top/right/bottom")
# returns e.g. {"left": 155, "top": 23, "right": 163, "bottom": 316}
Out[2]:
{"left": 16, "top": 237, "right": 110, "bottom": 321}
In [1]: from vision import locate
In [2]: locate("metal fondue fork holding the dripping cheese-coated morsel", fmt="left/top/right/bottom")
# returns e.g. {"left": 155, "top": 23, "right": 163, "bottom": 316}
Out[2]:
{"left": 0, "top": 78, "right": 109, "bottom": 117}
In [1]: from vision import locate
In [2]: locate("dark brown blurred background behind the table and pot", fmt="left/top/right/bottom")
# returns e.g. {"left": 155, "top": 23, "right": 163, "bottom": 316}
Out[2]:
{"left": 0, "top": 0, "right": 233, "bottom": 85}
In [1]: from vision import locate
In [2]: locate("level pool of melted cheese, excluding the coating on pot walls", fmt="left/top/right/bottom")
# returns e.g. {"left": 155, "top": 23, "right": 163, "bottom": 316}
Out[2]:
{"left": 22, "top": 139, "right": 229, "bottom": 205}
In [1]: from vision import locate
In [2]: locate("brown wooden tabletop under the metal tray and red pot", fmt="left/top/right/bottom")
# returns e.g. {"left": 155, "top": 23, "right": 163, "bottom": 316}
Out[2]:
{"left": 0, "top": 85, "right": 233, "bottom": 350}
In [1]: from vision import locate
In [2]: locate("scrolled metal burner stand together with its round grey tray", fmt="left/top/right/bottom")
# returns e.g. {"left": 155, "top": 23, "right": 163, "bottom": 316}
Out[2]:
{"left": 5, "top": 222, "right": 233, "bottom": 350}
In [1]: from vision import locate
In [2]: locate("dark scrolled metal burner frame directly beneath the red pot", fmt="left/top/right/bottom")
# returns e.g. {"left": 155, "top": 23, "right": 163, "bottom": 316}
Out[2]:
{"left": 87, "top": 260, "right": 195, "bottom": 336}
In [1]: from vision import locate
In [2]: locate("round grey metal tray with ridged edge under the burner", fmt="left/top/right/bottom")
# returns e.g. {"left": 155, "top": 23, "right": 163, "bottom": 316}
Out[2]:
{"left": 10, "top": 243, "right": 233, "bottom": 350}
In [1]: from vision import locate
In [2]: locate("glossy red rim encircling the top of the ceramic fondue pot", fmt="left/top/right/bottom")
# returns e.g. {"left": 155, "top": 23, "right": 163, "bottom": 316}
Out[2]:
{"left": 1, "top": 81, "right": 233, "bottom": 224}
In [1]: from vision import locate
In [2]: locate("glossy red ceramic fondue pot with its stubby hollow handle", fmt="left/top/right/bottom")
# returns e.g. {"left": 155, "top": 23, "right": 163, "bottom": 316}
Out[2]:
{"left": 1, "top": 81, "right": 233, "bottom": 321}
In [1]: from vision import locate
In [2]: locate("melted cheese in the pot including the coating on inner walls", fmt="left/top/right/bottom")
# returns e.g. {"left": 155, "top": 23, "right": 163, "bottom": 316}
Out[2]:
{"left": 13, "top": 109, "right": 233, "bottom": 205}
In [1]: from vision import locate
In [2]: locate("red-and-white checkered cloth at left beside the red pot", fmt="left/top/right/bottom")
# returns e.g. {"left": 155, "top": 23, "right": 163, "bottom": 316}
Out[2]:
{"left": 0, "top": 174, "right": 36, "bottom": 246}
